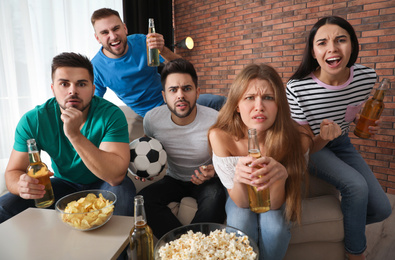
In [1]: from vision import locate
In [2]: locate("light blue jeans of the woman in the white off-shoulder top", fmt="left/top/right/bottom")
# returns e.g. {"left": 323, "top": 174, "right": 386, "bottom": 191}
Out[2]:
{"left": 225, "top": 197, "right": 291, "bottom": 260}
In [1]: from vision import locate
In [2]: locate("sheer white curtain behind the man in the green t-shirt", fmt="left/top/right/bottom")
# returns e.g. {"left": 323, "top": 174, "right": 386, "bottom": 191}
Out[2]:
{"left": 0, "top": 0, "right": 123, "bottom": 190}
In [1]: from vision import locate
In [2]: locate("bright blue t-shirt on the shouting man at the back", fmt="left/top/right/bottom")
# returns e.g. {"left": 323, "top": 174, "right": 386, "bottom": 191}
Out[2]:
{"left": 92, "top": 34, "right": 164, "bottom": 117}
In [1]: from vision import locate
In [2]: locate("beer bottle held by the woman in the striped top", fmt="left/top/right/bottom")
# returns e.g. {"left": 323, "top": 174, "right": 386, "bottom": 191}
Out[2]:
{"left": 354, "top": 78, "right": 390, "bottom": 139}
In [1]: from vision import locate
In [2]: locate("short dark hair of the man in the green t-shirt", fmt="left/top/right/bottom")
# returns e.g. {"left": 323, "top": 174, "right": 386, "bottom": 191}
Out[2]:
{"left": 51, "top": 52, "right": 93, "bottom": 82}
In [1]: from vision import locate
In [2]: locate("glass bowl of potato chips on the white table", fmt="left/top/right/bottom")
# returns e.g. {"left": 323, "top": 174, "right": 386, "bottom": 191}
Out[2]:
{"left": 55, "top": 190, "right": 117, "bottom": 231}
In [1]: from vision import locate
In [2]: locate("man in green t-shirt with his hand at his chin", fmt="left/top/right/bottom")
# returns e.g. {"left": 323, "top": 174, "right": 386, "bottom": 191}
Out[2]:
{"left": 0, "top": 53, "right": 136, "bottom": 223}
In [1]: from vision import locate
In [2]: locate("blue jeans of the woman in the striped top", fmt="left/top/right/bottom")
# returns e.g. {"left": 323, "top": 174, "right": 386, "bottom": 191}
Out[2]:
{"left": 309, "top": 135, "right": 391, "bottom": 254}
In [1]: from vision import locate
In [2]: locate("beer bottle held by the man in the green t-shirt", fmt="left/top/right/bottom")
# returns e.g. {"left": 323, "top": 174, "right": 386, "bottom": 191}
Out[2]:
{"left": 27, "top": 139, "right": 55, "bottom": 208}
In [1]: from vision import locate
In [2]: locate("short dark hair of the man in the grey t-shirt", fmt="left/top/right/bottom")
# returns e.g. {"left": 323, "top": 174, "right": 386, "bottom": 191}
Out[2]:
{"left": 161, "top": 59, "right": 198, "bottom": 90}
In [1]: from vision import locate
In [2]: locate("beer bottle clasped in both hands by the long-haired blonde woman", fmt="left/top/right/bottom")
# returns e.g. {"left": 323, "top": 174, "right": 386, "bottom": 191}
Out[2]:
{"left": 247, "top": 129, "right": 270, "bottom": 213}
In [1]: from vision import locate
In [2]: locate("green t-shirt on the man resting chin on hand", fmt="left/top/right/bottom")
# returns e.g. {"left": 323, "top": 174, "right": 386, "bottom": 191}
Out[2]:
{"left": 14, "top": 96, "right": 129, "bottom": 184}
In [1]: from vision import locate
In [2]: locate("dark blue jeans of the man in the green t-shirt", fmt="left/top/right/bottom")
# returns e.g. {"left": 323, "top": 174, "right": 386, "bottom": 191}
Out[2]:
{"left": 0, "top": 175, "right": 136, "bottom": 223}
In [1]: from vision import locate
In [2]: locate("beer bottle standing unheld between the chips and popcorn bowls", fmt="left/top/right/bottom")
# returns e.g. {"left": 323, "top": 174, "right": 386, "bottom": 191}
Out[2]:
{"left": 129, "top": 195, "right": 154, "bottom": 260}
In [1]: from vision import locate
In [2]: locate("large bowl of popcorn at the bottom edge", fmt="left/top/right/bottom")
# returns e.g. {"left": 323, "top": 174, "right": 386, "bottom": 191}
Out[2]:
{"left": 154, "top": 223, "right": 259, "bottom": 260}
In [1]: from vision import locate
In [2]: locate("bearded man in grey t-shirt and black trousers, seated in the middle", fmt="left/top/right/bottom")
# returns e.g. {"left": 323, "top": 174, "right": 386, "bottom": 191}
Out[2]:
{"left": 139, "top": 59, "right": 226, "bottom": 238}
